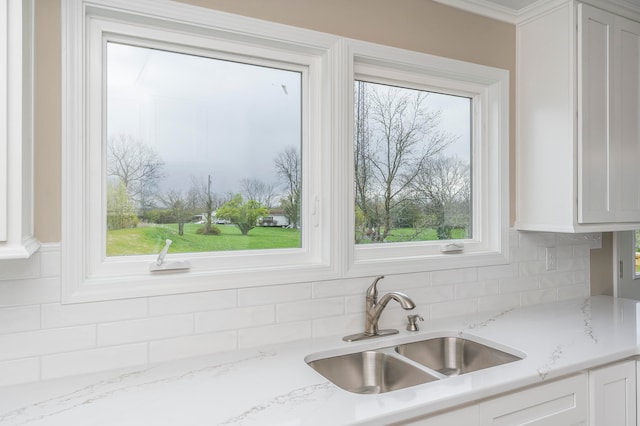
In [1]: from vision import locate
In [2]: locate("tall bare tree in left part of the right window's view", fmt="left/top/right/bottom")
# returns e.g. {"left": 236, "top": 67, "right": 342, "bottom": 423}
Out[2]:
{"left": 356, "top": 83, "right": 454, "bottom": 242}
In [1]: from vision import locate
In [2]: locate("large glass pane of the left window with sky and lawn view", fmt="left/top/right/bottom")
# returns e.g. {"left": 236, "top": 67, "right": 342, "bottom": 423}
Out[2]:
{"left": 105, "top": 42, "right": 302, "bottom": 256}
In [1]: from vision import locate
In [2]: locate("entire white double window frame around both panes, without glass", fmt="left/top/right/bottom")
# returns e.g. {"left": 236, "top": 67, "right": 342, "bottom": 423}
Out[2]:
{"left": 62, "top": 0, "right": 509, "bottom": 303}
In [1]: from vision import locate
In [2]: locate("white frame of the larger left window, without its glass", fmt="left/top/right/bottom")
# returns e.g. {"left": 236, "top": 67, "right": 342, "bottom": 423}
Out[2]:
{"left": 62, "top": 0, "right": 337, "bottom": 303}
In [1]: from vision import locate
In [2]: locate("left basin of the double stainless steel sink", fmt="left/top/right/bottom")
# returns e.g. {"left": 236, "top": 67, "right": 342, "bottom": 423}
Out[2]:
{"left": 309, "top": 351, "right": 437, "bottom": 394}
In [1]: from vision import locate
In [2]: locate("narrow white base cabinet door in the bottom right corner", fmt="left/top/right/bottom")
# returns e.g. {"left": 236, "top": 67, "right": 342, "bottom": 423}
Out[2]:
{"left": 589, "top": 360, "right": 636, "bottom": 426}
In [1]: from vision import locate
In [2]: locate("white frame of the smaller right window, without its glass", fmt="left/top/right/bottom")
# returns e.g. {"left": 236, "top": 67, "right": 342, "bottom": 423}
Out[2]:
{"left": 345, "top": 41, "right": 509, "bottom": 276}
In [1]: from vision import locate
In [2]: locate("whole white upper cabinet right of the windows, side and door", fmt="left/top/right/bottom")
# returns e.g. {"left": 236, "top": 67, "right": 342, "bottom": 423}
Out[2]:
{"left": 515, "top": 1, "right": 640, "bottom": 232}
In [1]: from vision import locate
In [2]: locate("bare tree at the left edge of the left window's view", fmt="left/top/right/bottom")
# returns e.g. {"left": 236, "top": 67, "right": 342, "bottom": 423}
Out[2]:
{"left": 107, "top": 134, "right": 164, "bottom": 211}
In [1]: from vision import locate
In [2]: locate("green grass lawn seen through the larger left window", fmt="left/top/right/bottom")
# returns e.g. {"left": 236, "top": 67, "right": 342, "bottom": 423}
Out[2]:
{"left": 107, "top": 223, "right": 300, "bottom": 256}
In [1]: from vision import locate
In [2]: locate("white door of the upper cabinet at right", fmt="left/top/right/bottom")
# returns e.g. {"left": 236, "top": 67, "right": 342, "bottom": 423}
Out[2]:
{"left": 578, "top": 4, "right": 640, "bottom": 223}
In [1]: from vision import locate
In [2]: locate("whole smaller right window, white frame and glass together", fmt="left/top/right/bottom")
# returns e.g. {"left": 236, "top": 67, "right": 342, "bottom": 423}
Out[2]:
{"left": 345, "top": 41, "right": 509, "bottom": 275}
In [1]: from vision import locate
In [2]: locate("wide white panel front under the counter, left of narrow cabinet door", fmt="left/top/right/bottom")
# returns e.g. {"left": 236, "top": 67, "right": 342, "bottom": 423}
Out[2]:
{"left": 480, "top": 374, "right": 588, "bottom": 426}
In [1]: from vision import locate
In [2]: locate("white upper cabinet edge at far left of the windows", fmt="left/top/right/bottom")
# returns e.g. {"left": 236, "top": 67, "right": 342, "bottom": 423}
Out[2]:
{"left": 0, "top": 0, "right": 39, "bottom": 259}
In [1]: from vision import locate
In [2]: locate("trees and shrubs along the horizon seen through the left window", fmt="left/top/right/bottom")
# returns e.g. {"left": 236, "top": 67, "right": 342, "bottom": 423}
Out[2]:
{"left": 107, "top": 135, "right": 302, "bottom": 235}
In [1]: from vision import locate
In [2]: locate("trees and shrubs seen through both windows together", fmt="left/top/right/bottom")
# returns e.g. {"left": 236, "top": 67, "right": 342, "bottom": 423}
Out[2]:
{"left": 107, "top": 81, "right": 472, "bottom": 243}
